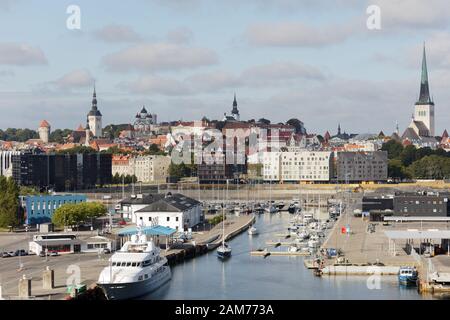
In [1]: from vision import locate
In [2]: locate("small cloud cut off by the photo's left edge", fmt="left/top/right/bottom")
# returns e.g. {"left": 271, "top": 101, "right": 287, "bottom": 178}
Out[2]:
{"left": 0, "top": 43, "right": 48, "bottom": 66}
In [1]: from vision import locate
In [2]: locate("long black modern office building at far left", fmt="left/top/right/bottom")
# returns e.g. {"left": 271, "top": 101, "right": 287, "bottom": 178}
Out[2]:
{"left": 12, "top": 153, "right": 112, "bottom": 192}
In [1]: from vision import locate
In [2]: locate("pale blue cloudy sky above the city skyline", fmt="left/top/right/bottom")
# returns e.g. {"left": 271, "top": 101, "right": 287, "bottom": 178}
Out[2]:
{"left": 0, "top": 0, "right": 450, "bottom": 134}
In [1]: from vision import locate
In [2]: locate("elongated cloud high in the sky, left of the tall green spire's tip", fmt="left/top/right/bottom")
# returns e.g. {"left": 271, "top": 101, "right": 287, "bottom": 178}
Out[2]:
{"left": 245, "top": 22, "right": 354, "bottom": 47}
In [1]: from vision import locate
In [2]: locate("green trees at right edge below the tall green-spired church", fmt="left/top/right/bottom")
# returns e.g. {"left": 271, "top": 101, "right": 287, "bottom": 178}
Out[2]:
{"left": 381, "top": 140, "right": 450, "bottom": 180}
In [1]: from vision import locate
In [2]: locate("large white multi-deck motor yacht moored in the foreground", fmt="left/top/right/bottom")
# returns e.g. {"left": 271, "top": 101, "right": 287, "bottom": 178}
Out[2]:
{"left": 97, "top": 229, "right": 172, "bottom": 300}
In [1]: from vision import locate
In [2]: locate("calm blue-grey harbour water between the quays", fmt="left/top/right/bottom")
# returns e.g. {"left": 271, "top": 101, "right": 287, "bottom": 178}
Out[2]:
{"left": 145, "top": 213, "right": 428, "bottom": 300}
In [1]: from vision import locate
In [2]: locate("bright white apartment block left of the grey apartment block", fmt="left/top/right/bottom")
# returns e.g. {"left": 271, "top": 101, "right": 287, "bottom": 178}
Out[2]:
{"left": 263, "top": 151, "right": 333, "bottom": 182}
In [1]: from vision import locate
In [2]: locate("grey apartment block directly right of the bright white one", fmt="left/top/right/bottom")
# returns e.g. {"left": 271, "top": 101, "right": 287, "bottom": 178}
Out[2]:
{"left": 336, "top": 151, "right": 388, "bottom": 183}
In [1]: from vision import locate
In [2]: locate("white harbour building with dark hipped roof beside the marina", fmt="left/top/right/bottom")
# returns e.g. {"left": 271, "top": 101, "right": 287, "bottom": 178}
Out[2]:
{"left": 120, "top": 193, "right": 204, "bottom": 231}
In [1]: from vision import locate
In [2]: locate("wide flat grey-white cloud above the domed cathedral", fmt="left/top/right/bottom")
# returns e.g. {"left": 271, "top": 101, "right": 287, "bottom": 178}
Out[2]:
{"left": 102, "top": 43, "right": 218, "bottom": 72}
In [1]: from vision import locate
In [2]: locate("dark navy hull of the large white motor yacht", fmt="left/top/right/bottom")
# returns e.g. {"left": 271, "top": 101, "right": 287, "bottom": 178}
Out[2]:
{"left": 97, "top": 266, "right": 172, "bottom": 300}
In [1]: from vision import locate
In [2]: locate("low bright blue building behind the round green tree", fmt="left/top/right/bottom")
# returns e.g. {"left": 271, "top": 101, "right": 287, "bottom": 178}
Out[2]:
{"left": 21, "top": 194, "right": 87, "bottom": 225}
